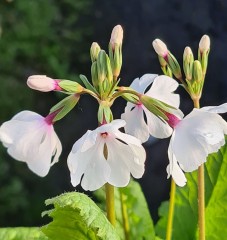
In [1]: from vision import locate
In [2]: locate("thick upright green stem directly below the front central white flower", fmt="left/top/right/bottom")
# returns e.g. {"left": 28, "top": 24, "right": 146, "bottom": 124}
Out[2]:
{"left": 105, "top": 183, "right": 116, "bottom": 226}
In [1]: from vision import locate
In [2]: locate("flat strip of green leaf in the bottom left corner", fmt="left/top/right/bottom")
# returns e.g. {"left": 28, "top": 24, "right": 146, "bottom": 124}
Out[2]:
{"left": 0, "top": 227, "right": 48, "bottom": 240}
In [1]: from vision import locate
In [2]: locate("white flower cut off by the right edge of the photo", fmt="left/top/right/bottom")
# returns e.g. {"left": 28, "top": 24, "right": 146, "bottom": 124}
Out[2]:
{"left": 167, "top": 103, "right": 227, "bottom": 186}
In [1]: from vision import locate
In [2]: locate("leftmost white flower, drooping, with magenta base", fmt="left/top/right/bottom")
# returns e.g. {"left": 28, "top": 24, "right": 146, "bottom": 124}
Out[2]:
{"left": 0, "top": 111, "right": 62, "bottom": 177}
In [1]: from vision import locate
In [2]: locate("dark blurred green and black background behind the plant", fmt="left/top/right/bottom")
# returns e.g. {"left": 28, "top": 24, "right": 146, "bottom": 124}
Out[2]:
{"left": 0, "top": 0, "right": 227, "bottom": 226}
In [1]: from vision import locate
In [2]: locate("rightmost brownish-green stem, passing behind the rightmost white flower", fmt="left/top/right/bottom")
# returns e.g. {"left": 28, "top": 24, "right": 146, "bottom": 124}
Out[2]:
{"left": 193, "top": 98, "right": 205, "bottom": 240}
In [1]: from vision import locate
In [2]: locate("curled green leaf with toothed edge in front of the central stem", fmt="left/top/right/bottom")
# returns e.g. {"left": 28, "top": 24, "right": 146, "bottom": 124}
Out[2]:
{"left": 41, "top": 192, "right": 120, "bottom": 240}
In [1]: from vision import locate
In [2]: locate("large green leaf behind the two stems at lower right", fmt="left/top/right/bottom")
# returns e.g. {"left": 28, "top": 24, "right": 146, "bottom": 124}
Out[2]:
{"left": 156, "top": 140, "right": 227, "bottom": 240}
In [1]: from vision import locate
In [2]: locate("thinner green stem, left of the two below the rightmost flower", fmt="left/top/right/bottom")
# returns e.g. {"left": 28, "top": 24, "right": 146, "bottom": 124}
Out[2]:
{"left": 166, "top": 178, "right": 176, "bottom": 240}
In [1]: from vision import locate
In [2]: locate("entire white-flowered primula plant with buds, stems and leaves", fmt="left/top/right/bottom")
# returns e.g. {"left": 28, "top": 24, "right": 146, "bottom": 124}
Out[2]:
{"left": 0, "top": 25, "right": 227, "bottom": 240}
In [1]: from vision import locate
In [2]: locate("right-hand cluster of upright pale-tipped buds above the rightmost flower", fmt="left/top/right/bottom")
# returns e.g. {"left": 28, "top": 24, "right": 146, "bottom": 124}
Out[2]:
{"left": 153, "top": 35, "right": 210, "bottom": 100}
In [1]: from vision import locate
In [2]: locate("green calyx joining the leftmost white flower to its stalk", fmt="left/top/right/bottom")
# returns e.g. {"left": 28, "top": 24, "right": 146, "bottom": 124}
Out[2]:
{"left": 50, "top": 94, "right": 80, "bottom": 122}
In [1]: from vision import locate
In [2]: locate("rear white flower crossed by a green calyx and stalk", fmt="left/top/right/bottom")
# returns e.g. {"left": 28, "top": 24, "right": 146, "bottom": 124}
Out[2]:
{"left": 121, "top": 74, "right": 180, "bottom": 142}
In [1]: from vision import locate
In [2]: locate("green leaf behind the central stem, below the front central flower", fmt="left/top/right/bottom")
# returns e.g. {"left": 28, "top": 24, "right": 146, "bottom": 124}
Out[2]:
{"left": 95, "top": 180, "right": 155, "bottom": 240}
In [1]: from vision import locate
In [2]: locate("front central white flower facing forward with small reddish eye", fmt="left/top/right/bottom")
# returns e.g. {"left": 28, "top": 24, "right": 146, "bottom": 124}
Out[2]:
{"left": 68, "top": 120, "right": 146, "bottom": 191}
